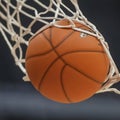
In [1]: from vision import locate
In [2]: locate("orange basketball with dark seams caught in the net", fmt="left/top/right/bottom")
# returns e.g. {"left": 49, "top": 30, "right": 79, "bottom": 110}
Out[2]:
{"left": 25, "top": 20, "right": 109, "bottom": 103}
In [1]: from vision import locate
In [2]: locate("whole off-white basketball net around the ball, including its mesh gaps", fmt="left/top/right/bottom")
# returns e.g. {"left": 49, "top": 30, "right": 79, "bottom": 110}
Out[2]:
{"left": 0, "top": 0, "right": 120, "bottom": 94}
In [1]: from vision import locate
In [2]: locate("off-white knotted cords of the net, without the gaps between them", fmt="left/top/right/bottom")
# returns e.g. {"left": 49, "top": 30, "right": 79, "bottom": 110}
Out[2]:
{"left": 0, "top": 0, "right": 120, "bottom": 94}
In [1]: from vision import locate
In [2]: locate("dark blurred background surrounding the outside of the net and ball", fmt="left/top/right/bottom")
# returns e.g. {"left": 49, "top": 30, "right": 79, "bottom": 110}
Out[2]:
{"left": 0, "top": 0, "right": 120, "bottom": 120}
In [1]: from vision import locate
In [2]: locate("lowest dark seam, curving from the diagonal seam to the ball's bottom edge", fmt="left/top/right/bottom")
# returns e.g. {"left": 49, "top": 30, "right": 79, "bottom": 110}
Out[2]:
{"left": 60, "top": 65, "right": 72, "bottom": 103}
